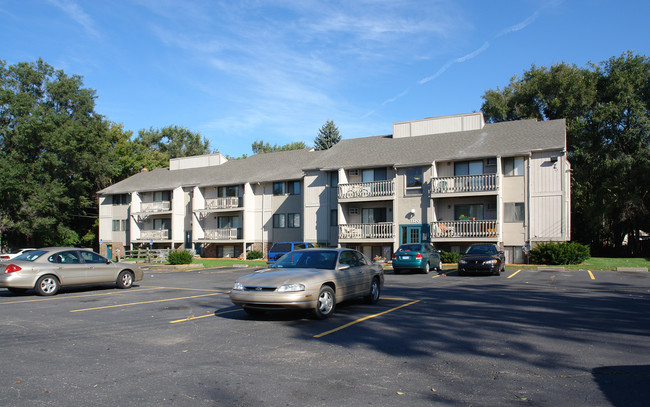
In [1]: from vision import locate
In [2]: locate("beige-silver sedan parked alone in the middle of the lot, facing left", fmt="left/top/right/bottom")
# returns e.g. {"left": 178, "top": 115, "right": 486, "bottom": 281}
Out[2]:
{"left": 230, "top": 249, "right": 384, "bottom": 319}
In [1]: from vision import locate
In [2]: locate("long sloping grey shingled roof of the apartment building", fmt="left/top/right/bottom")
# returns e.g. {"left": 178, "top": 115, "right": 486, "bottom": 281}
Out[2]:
{"left": 99, "top": 119, "right": 566, "bottom": 195}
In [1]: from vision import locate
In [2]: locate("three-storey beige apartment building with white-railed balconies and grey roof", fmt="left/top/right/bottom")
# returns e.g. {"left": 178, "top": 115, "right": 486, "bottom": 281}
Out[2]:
{"left": 99, "top": 113, "right": 571, "bottom": 263}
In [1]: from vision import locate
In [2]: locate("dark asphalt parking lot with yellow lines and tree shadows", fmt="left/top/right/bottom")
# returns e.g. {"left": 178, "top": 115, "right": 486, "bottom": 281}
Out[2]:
{"left": 0, "top": 268, "right": 650, "bottom": 406}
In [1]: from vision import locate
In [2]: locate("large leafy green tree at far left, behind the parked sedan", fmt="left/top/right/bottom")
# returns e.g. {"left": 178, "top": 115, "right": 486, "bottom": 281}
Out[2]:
{"left": 0, "top": 59, "right": 116, "bottom": 246}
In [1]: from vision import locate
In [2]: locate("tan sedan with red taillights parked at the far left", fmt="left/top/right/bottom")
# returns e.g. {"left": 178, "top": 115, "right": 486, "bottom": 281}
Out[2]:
{"left": 0, "top": 247, "right": 144, "bottom": 295}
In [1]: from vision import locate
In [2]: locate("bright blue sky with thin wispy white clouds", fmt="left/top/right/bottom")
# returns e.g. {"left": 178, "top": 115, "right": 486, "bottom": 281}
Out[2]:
{"left": 0, "top": 0, "right": 650, "bottom": 156}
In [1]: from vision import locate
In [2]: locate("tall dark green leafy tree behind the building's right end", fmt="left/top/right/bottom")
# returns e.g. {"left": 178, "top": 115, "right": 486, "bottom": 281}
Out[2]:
{"left": 482, "top": 52, "right": 650, "bottom": 255}
